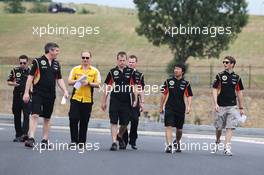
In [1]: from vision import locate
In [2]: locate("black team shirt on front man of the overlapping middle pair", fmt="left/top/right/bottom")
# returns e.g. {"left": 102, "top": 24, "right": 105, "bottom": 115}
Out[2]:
{"left": 104, "top": 67, "right": 135, "bottom": 103}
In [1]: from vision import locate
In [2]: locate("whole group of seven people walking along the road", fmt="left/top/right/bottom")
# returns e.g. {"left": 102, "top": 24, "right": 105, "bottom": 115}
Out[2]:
{"left": 7, "top": 43, "right": 244, "bottom": 155}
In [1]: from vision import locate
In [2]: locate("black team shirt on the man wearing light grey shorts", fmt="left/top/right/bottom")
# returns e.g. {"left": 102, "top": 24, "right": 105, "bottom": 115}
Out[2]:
{"left": 213, "top": 71, "right": 244, "bottom": 106}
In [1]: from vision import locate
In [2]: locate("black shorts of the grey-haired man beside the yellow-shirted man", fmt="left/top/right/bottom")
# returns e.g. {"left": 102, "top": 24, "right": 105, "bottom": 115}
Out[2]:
{"left": 31, "top": 94, "right": 55, "bottom": 119}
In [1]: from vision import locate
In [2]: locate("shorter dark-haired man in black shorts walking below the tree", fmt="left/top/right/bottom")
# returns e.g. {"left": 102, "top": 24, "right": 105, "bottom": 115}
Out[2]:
{"left": 160, "top": 64, "right": 193, "bottom": 153}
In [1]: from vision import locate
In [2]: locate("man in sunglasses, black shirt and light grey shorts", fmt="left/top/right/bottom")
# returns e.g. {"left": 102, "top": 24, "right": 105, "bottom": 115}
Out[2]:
{"left": 212, "top": 56, "right": 244, "bottom": 156}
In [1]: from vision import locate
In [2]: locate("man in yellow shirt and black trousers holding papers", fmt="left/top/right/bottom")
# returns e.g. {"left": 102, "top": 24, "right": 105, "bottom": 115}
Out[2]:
{"left": 68, "top": 51, "right": 101, "bottom": 147}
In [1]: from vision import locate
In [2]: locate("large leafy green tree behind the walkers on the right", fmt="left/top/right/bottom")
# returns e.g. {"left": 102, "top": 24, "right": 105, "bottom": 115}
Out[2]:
{"left": 134, "top": 0, "right": 248, "bottom": 73}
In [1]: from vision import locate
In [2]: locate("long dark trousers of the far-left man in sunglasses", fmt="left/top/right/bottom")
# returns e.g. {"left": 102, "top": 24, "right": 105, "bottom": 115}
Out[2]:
{"left": 12, "top": 93, "right": 30, "bottom": 137}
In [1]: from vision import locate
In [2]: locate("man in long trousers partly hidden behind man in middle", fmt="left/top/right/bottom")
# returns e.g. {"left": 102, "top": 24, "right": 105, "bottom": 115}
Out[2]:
{"left": 123, "top": 55, "right": 145, "bottom": 150}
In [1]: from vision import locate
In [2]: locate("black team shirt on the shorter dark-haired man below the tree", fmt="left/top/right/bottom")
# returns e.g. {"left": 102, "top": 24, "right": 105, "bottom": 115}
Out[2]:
{"left": 162, "top": 77, "right": 193, "bottom": 115}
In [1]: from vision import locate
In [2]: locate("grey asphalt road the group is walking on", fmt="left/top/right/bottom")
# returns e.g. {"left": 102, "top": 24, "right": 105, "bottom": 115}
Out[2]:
{"left": 0, "top": 124, "right": 264, "bottom": 175}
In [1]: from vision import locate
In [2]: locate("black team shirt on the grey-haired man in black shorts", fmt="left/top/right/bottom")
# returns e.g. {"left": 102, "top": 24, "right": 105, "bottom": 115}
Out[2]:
{"left": 30, "top": 55, "right": 62, "bottom": 98}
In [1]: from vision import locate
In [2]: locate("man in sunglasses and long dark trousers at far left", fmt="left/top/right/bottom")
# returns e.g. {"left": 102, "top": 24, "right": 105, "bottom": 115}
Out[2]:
{"left": 7, "top": 55, "right": 30, "bottom": 142}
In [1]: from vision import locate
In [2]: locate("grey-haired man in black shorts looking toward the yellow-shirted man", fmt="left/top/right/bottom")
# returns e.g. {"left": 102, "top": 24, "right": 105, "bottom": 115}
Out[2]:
{"left": 23, "top": 43, "right": 69, "bottom": 148}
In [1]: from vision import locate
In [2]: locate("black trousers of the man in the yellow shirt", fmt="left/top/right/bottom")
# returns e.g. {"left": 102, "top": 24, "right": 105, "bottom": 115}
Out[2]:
{"left": 69, "top": 100, "right": 92, "bottom": 143}
